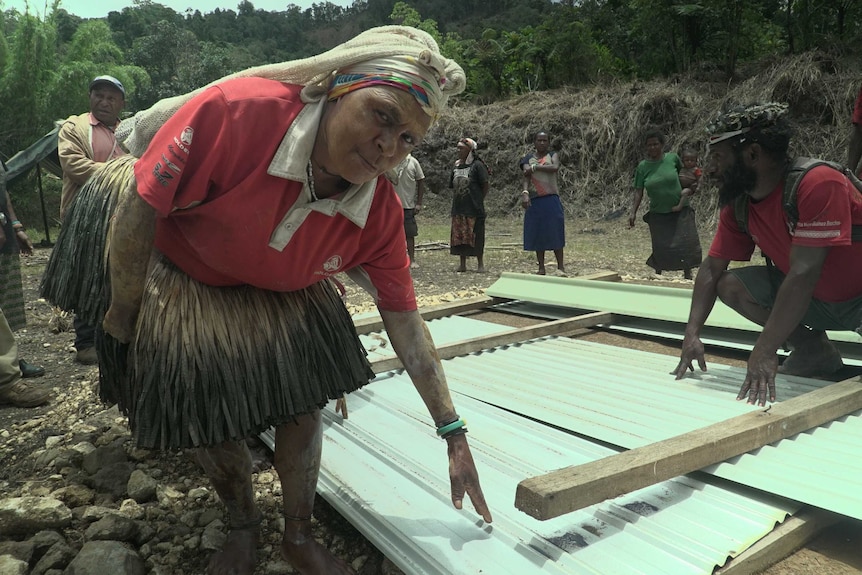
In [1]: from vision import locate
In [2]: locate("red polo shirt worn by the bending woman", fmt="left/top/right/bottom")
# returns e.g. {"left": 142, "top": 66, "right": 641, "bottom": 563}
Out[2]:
{"left": 135, "top": 78, "right": 416, "bottom": 311}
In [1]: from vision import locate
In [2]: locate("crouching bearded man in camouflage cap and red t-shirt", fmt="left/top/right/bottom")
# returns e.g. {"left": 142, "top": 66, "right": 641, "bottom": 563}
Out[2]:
{"left": 673, "top": 103, "right": 862, "bottom": 405}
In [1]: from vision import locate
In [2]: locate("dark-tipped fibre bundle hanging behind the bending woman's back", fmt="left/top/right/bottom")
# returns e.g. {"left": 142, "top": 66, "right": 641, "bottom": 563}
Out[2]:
{"left": 39, "top": 156, "right": 136, "bottom": 325}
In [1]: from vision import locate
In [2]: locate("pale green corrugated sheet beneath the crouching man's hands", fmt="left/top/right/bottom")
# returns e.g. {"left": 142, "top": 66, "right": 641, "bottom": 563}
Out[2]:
{"left": 438, "top": 338, "right": 862, "bottom": 519}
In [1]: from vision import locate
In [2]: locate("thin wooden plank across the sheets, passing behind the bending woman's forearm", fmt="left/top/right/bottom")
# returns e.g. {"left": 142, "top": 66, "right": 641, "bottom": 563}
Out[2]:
{"left": 371, "top": 312, "right": 614, "bottom": 373}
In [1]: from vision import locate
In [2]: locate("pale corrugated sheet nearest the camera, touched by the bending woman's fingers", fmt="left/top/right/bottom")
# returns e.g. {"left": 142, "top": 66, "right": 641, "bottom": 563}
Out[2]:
{"left": 308, "top": 375, "right": 798, "bottom": 575}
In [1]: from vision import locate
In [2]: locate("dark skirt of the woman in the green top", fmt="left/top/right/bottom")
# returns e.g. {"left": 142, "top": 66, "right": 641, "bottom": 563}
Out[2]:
{"left": 644, "top": 207, "right": 703, "bottom": 271}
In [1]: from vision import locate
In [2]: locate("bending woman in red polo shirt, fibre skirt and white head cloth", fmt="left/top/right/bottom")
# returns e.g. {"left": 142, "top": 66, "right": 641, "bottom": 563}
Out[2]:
{"left": 45, "top": 27, "right": 491, "bottom": 575}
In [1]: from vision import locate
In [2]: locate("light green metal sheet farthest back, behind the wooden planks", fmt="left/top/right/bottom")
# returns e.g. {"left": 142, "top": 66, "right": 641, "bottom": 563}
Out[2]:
{"left": 486, "top": 272, "right": 862, "bottom": 348}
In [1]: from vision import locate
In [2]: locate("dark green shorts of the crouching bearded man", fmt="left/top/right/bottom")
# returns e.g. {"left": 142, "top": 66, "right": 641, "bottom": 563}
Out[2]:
{"left": 727, "top": 266, "right": 862, "bottom": 331}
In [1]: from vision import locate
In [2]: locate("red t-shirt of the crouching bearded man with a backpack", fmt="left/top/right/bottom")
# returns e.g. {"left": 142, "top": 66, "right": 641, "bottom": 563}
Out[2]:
{"left": 709, "top": 166, "right": 862, "bottom": 302}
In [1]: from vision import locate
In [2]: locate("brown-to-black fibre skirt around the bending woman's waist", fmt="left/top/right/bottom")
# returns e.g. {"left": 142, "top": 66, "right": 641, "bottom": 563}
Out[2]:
{"left": 96, "top": 254, "right": 374, "bottom": 449}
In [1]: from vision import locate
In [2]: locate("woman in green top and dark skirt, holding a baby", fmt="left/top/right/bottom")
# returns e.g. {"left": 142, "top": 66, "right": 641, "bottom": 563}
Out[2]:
{"left": 629, "top": 130, "right": 702, "bottom": 279}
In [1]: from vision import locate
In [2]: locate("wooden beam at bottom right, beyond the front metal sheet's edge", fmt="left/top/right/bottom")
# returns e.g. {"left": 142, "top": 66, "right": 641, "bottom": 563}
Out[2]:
{"left": 713, "top": 507, "right": 840, "bottom": 575}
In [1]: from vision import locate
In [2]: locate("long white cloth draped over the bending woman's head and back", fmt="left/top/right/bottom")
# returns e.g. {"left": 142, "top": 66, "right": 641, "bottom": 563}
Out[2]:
{"left": 116, "top": 26, "right": 467, "bottom": 157}
